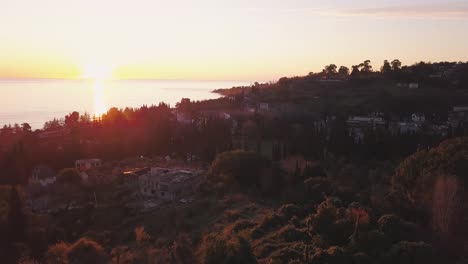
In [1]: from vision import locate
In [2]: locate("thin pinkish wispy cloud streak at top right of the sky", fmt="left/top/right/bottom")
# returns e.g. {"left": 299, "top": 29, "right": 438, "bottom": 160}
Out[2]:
{"left": 320, "top": 3, "right": 468, "bottom": 18}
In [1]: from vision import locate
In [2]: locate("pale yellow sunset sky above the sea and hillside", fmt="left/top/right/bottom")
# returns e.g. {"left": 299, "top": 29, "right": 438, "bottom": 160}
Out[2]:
{"left": 0, "top": 0, "right": 468, "bottom": 81}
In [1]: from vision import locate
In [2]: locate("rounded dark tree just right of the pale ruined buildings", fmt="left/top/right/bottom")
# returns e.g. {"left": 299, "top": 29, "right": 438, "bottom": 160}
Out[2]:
{"left": 208, "top": 150, "right": 268, "bottom": 187}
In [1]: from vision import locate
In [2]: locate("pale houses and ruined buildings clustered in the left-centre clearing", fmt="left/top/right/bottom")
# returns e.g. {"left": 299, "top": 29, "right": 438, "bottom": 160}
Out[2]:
{"left": 28, "top": 159, "right": 203, "bottom": 211}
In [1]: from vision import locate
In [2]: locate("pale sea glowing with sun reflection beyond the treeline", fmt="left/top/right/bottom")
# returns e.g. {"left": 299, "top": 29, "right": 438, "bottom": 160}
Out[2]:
{"left": 0, "top": 79, "right": 251, "bottom": 129}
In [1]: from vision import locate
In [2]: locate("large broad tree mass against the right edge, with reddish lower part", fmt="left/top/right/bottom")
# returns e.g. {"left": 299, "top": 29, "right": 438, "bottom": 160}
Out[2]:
{"left": 392, "top": 138, "right": 468, "bottom": 252}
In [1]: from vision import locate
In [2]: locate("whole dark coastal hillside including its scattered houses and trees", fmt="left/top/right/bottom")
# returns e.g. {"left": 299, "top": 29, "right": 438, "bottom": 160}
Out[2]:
{"left": 0, "top": 61, "right": 468, "bottom": 264}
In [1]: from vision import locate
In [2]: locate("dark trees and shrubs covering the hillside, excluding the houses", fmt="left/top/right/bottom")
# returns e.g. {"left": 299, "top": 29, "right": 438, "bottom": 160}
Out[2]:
{"left": 0, "top": 60, "right": 468, "bottom": 264}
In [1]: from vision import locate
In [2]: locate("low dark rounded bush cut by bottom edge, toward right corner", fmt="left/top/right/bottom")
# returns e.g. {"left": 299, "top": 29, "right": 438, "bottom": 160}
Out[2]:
{"left": 390, "top": 241, "right": 434, "bottom": 264}
